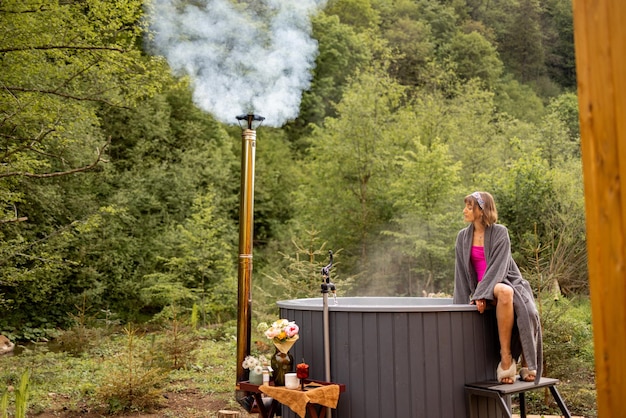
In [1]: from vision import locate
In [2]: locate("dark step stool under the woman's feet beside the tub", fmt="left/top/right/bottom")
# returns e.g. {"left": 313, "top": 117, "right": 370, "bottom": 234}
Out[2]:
{"left": 465, "top": 377, "right": 572, "bottom": 418}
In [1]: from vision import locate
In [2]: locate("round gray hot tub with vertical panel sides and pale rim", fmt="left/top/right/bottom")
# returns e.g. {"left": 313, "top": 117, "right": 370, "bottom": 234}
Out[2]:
{"left": 278, "top": 297, "right": 499, "bottom": 418}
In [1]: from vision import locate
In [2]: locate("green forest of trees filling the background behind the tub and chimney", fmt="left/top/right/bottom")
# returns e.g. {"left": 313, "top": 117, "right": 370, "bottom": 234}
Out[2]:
{"left": 0, "top": 0, "right": 588, "bottom": 339}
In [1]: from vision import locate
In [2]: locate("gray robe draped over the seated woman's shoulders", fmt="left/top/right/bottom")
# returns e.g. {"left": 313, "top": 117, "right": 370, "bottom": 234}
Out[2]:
{"left": 454, "top": 224, "right": 543, "bottom": 384}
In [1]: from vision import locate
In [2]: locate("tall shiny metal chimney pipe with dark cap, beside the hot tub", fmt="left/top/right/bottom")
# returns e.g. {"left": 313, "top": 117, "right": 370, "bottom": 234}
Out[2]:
{"left": 237, "top": 114, "right": 265, "bottom": 383}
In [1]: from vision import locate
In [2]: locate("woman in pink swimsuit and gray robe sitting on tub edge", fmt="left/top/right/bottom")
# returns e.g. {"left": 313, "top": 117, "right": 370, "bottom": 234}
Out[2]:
{"left": 453, "top": 192, "right": 543, "bottom": 384}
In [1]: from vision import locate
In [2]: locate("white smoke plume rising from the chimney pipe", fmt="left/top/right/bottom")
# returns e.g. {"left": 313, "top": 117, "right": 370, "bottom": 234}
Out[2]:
{"left": 148, "top": 0, "right": 326, "bottom": 127}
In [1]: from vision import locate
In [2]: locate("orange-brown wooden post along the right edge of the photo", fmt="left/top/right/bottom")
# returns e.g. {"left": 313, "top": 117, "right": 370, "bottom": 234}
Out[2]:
{"left": 573, "top": 0, "right": 626, "bottom": 418}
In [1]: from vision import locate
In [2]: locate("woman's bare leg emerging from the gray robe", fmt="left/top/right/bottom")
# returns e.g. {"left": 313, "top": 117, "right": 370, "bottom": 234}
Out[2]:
{"left": 493, "top": 283, "right": 515, "bottom": 383}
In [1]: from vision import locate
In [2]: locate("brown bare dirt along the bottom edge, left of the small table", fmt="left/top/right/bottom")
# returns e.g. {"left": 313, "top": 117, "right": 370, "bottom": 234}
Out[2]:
{"left": 29, "top": 389, "right": 257, "bottom": 418}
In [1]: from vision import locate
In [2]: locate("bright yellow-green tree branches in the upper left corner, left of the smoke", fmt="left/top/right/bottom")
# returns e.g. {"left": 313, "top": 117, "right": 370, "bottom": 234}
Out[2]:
{"left": 0, "top": 0, "right": 166, "bottom": 221}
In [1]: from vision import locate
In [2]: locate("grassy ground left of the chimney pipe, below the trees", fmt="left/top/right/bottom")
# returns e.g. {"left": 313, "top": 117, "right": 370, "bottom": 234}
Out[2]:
{"left": 0, "top": 323, "right": 249, "bottom": 417}
